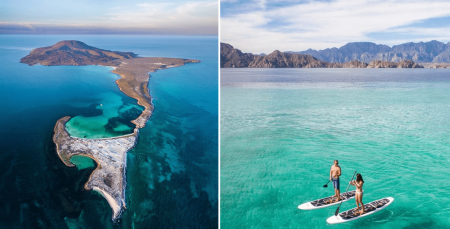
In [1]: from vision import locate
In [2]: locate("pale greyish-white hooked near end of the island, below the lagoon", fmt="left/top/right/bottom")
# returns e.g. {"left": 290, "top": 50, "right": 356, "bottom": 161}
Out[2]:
{"left": 53, "top": 116, "right": 138, "bottom": 220}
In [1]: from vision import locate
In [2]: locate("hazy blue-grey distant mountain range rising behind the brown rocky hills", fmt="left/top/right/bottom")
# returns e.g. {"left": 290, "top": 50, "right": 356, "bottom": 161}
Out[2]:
{"left": 298, "top": 40, "right": 450, "bottom": 63}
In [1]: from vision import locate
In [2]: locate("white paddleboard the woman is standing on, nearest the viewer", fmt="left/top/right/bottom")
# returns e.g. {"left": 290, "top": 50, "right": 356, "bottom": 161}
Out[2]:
{"left": 327, "top": 197, "right": 394, "bottom": 224}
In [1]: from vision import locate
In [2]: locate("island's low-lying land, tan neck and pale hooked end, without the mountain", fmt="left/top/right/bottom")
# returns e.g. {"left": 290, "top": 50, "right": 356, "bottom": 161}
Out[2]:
{"left": 53, "top": 57, "right": 199, "bottom": 221}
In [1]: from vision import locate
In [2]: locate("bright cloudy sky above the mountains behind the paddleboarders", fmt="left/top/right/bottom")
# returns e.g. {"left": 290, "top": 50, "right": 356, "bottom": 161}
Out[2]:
{"left": 220, "top": 0, "right": 450, "bottom": 53}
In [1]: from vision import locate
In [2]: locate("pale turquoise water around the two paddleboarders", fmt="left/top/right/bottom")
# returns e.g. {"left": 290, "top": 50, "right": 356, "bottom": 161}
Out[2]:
{"left": 220, "top": 69, "right": 450, "bottom": 228}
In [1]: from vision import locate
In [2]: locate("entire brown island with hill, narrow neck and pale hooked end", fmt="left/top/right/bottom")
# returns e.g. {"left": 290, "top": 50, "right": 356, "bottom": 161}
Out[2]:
{"left": 20, "top": 40, "right": 200, "bottom": 220}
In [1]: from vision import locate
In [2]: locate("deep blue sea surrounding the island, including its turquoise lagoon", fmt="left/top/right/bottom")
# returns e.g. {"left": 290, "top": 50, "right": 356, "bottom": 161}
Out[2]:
{"left": 0, "top": 35, "right": 218, "bottom": 228}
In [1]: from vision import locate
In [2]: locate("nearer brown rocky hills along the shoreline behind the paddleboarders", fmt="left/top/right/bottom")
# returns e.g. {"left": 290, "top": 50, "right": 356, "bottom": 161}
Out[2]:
{"left": 220, "top": 43, "right": 423, "bottom": 68}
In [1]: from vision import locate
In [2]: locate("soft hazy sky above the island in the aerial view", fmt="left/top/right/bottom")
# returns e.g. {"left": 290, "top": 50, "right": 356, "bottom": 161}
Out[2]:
{"left": 0, "top": 0, "right": 219, "bottom": 35}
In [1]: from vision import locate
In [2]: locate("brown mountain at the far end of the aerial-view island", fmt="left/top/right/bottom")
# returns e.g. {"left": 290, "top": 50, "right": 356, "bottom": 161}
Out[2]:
{"left": 20, "top": 40, "right": 137, "bottom": 66}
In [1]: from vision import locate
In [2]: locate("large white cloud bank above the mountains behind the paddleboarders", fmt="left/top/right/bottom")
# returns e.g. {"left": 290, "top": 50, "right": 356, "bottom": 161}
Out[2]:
{"left": 221, "top": 0, "right": 450, "bottom": 53}
